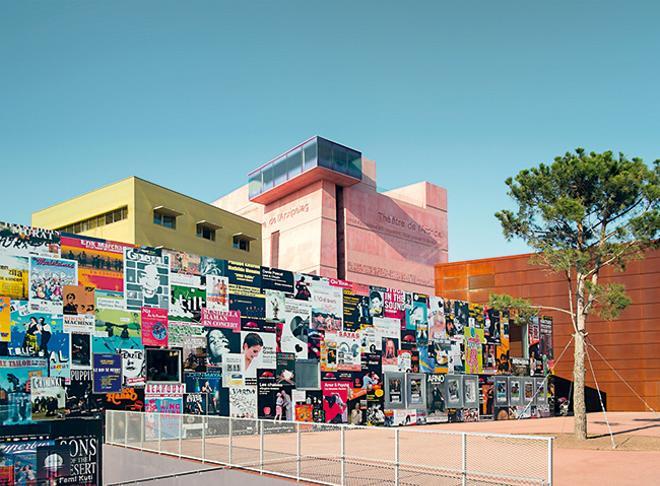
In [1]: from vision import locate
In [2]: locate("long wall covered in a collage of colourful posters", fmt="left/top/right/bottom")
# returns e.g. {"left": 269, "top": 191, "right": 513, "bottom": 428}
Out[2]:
{"left": 0, "top": 223, "right": 553, "bottom": 440}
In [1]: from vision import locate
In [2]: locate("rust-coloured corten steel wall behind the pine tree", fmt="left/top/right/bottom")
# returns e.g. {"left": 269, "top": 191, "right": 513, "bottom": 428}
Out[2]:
{"left": 435, "top": 251, "right": 660, "bottom": 410}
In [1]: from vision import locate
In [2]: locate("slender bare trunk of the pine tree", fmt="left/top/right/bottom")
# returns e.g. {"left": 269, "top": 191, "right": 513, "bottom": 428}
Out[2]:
{"left": 573, "top": 278, "right": 587, "bottom": 440}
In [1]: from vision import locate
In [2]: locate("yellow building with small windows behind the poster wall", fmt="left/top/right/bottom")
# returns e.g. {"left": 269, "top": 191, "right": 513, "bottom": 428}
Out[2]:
{"left": 32, "top": 177, "right": 261, "bottom": 264}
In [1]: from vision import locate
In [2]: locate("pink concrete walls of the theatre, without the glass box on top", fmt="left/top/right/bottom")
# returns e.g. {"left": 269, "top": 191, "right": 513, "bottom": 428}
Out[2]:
{"left": 213, "top": 159, "right": 447, "bottom": 294}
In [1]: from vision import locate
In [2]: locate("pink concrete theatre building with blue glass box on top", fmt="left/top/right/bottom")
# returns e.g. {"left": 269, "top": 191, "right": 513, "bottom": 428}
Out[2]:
{"left": 213, "top": 137, "right": 447, "bottom": 294}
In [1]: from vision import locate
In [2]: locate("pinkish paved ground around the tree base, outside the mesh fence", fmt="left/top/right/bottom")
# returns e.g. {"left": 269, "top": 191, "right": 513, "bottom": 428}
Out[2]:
{"left": 425, "top": 412, "right": 660, "bottom": 486}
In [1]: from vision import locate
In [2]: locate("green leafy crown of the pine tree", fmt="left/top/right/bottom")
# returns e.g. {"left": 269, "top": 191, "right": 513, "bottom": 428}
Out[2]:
{"left": 495, "top": 149, "right": 660, "bottom": 273}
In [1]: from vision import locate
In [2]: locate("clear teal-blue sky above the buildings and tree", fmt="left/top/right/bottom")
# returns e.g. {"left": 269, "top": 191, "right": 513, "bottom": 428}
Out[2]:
{"left": 0, "top": 0, "right": 660, "bottom": 261}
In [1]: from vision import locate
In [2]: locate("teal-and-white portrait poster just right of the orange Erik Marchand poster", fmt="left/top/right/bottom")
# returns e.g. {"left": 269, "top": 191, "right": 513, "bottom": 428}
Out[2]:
{"left": 124, "top": 248, "right": 170, "bottom": 311}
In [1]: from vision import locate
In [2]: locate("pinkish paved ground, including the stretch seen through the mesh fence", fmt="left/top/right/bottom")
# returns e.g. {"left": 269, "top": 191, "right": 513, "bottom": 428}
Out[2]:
{"left": 106, "top": 413, "right": 660, "bottom": 486}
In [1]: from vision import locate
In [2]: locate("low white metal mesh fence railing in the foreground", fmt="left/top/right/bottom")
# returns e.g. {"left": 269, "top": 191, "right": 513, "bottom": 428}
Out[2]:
{"left": 106, "top": 410, "right": 553, "bottom": 486}
